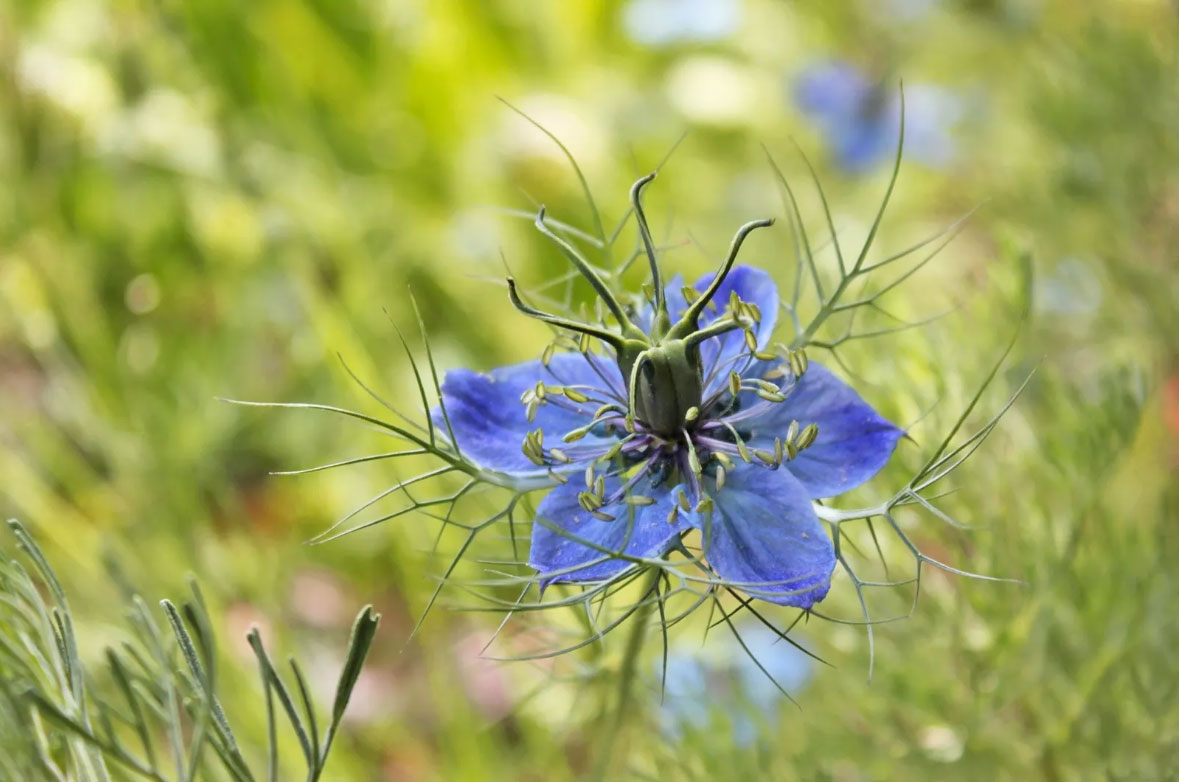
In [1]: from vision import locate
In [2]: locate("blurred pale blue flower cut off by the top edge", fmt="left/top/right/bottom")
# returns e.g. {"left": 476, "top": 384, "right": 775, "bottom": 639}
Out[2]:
{"left": 623, "top": 0, "right": 740, "bottom": 46}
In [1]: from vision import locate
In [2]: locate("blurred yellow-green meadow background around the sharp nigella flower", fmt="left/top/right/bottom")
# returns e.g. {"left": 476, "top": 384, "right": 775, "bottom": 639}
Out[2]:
{"left": 0, "top": 0, "right": 1179, "bottom": 781}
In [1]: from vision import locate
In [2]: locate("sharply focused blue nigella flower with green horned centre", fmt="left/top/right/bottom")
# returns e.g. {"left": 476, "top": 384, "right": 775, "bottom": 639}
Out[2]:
{"left": 434, "top": 175, "right": 902, "bottom": 609}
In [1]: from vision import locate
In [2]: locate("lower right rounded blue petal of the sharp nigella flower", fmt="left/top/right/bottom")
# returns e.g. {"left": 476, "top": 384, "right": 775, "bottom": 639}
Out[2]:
{"left": 697, "top": 465, "right": 835, "bottom": 609}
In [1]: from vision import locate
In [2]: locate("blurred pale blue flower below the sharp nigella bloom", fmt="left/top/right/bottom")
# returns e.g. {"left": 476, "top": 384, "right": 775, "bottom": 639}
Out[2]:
{"left": 656, "top": 625, "right": 814, "bottom": 747}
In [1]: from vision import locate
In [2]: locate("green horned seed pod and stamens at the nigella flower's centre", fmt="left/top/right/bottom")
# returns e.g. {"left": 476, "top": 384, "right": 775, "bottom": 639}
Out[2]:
{"left": 507, "top": 173, "right": 817, "bottom": 521}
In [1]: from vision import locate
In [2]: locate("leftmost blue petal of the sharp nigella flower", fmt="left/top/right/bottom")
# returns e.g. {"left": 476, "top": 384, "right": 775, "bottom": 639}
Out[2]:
{"left": 432, "top": 353, "right": 623, "bottom": 475}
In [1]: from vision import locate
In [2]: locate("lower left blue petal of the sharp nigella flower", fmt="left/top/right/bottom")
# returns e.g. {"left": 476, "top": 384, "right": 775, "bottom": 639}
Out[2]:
{"left": 528, "top": 478, "right": 689, "bottom": 585}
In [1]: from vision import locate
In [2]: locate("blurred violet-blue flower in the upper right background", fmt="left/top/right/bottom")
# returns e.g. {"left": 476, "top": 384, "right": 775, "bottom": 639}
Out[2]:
{"left": 795, "top": 61, "right": 962, "bottom": 173}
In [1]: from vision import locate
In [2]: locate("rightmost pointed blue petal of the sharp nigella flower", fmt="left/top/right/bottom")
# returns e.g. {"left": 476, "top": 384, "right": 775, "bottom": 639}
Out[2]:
{"left": 752, "top": 362, "right": 904, "bottom": 498}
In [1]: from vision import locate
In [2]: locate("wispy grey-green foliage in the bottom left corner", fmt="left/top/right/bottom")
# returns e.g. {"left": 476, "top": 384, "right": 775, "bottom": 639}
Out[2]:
{"left": 0, "top": 520, "right": 380, "bottom": 782}
